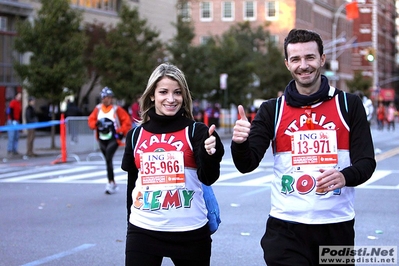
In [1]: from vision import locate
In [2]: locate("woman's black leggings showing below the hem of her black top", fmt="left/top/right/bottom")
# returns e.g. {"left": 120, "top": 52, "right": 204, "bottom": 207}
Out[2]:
{"left": 125, "top": 251, "right": 210, "bottom": 266}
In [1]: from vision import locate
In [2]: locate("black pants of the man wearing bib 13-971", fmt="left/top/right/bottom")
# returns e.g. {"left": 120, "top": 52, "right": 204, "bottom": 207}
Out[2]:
{"left": 261, "top": 217, "right": 355, "bottom": 266}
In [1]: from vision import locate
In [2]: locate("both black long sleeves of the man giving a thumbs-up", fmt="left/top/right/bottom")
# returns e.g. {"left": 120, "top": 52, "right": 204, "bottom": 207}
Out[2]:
{"left": 231, "top": 91, "right": 376, "bottom": 187}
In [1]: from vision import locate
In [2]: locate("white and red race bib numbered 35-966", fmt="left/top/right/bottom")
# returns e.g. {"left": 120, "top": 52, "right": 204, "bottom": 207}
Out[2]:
{"left": 139, "top": 151, "right": 186, "bottom": 191}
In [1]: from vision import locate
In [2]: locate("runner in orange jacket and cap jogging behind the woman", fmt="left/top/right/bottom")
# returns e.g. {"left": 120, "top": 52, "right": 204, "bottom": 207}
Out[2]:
{"left": 87, "top": 87, "right": 132, "bottom": 194}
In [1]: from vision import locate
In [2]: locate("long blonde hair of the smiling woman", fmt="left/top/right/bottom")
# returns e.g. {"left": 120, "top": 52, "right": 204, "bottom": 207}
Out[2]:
{"left": 140, "top": 63, "right": 194, "bottom": 123}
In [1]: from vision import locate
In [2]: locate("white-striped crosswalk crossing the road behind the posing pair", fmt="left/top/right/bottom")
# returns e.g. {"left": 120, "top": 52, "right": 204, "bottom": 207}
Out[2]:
{"left": 0, "top": 160, "right": 399, "bottom": 190}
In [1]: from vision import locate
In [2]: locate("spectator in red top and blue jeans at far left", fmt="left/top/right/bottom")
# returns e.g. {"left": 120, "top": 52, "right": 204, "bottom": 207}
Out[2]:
{"left": 7, "top": 92, "right": 22, "bottom": 156}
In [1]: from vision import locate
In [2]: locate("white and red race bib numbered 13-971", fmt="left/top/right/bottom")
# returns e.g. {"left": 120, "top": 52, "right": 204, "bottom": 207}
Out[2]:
{"left": 291, "top": 130, "right": 338, "bottom": 171}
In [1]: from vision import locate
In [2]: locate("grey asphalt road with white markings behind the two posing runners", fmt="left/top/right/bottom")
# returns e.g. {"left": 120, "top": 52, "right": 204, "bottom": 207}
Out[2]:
{"left": 0, "top": 125, "right": 399, "bottom": 266}
